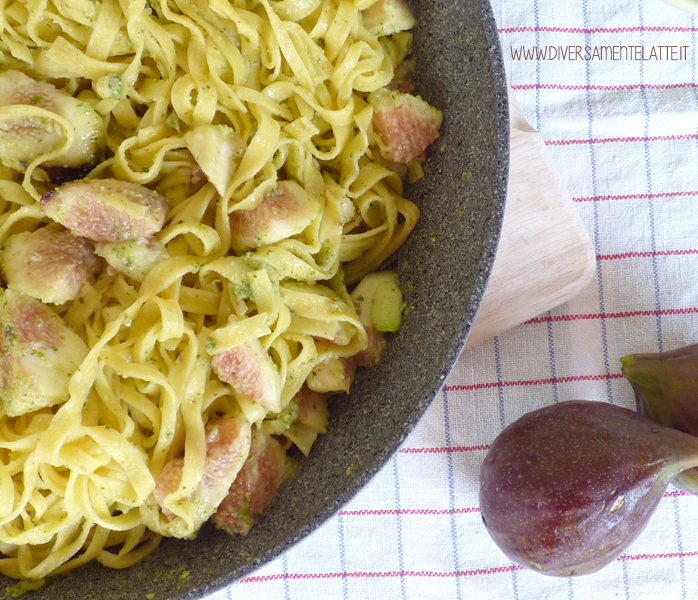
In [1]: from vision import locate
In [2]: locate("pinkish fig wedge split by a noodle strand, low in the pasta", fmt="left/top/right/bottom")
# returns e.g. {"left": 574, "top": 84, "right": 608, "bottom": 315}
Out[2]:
{"left": 153, "top": 417, "right": 251, "bottom": 531}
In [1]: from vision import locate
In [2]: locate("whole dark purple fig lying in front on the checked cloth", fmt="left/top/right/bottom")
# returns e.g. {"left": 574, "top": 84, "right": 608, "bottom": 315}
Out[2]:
{"left": 480, "top": 400, "right": 698, "bottom": 576}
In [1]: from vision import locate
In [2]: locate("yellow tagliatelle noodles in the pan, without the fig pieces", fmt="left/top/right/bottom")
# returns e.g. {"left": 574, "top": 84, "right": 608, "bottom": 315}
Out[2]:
{"left": 0, "top": 0, "right": 438, "bottom": 579}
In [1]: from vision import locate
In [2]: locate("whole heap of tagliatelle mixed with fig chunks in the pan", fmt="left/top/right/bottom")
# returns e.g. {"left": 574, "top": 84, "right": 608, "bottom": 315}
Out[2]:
{"left": 0, "top": 0, "right": 440, "bottom": 579}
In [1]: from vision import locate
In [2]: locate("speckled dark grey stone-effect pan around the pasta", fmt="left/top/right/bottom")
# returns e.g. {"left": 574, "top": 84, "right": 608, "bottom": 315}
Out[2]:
{"left": 0, "top": 0, "right": 509, "bottom": 600}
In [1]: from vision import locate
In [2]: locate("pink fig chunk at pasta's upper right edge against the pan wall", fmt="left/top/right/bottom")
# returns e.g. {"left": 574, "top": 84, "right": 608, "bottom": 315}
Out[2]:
{"left": 368, "top": 89, "right": 443, "bottom": 164}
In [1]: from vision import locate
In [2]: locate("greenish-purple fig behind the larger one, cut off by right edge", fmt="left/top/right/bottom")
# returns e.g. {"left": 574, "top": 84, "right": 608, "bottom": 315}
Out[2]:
{"left": 620, "top": 344, "right": 698, "bottom": 494}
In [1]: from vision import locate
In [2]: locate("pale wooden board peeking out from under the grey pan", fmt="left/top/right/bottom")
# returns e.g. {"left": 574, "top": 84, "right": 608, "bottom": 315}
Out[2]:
{"left": 466, "top": 89, "right": 596, "bottom": 347}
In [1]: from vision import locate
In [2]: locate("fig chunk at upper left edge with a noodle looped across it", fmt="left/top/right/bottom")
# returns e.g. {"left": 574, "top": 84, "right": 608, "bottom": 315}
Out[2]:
{"left": 0, "top": 71, "right": 106, "bottom": 175}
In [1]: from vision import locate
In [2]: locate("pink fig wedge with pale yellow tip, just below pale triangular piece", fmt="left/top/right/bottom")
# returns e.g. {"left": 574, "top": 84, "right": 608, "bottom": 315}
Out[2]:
{"left": 230, "top": 181, "right": 322, "bottom": 251}
